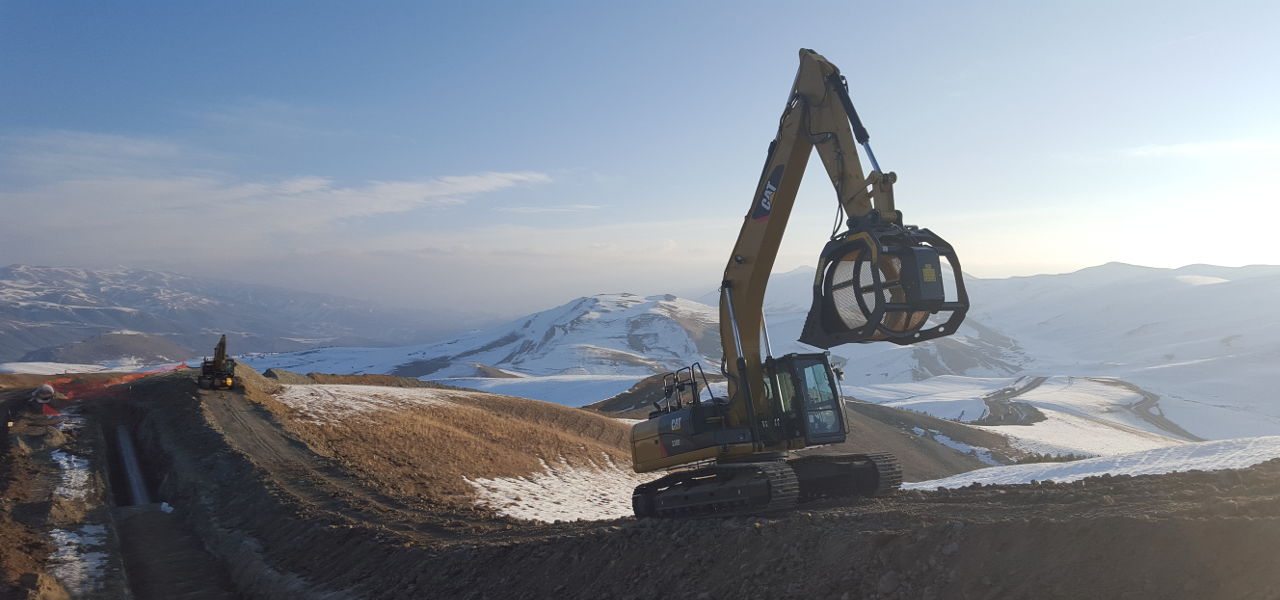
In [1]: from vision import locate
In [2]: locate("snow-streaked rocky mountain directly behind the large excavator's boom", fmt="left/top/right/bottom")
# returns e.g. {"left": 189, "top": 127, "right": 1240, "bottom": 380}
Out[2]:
{"left": 247, "top": 264, "right": 1028, "bottom": 383}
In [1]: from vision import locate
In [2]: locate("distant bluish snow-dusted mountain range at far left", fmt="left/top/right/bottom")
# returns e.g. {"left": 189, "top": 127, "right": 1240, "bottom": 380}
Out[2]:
{"left": 0, "top": 265, "right": 455, "bottom": 361}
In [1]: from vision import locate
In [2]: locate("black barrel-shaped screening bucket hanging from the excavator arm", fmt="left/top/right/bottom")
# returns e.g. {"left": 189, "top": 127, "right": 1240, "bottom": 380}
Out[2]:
{"left": 800, "top": 212, "right": 969, "bottom": 348}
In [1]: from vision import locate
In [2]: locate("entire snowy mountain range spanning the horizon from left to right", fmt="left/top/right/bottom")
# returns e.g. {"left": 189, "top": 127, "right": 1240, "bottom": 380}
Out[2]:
{"left": 12, "top": 264, "right": 1280, "bottom": 439}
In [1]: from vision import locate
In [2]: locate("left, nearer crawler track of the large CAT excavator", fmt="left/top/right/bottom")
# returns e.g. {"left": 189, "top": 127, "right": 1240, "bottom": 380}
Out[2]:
{"left": 631, "top": 461, "right": 800, "bottom": 518}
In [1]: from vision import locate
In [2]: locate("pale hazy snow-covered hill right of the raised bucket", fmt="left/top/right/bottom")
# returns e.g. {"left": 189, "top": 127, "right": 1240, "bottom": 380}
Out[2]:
{"left": 972, "top": 262, "right": 1280, "bottom": 439}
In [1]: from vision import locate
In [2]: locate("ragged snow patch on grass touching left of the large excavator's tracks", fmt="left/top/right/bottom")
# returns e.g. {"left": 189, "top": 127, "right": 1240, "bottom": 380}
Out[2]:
{"left": 466, "top": 457, "right": 655, "bottom": 523}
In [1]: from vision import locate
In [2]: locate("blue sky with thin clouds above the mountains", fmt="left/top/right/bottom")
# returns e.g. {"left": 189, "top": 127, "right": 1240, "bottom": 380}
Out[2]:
{"left": 0, "top": 1, "right": 1280, "bottom": 315}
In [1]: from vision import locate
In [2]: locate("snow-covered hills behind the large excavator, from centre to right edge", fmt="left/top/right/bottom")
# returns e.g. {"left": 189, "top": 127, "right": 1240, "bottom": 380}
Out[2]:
{"left": 241, "top": 264, "right": 1280, "bottom": 439}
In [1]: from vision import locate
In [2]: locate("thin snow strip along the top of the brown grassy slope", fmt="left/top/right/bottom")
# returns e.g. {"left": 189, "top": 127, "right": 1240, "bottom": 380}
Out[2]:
{"left": 276, "top": 384, "right": 477, "bottom": 422}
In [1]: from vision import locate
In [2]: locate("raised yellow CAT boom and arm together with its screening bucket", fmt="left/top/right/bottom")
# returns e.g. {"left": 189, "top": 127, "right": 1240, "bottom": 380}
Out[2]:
{"left": 719, "top": 50, "right": 968, "bottom": 450}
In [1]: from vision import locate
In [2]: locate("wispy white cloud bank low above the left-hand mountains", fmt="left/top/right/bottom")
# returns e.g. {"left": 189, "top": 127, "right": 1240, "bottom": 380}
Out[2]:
{"left": 0, "top": 132, "right": 552, "bottom": 264}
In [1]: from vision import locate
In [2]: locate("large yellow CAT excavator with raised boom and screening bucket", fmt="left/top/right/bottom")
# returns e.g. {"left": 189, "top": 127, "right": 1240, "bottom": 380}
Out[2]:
{"left": 631, "top": 50, "right": 969, "bottom": 518}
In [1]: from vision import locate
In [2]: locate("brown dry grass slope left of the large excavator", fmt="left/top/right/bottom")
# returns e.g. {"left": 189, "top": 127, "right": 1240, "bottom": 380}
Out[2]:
{"left": 242, "top": 368, "right": 630, "bottom": 510}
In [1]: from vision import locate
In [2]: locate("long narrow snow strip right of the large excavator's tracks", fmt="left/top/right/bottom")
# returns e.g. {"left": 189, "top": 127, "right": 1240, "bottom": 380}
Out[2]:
{"left": 902, "top": 436, "right": 1280, "bottom": 490}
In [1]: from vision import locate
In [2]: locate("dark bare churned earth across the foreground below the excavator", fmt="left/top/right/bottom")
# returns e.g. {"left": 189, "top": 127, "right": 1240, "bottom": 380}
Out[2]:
{"left": 0, "top": 372, "right": 1280, "bottom": 599}
